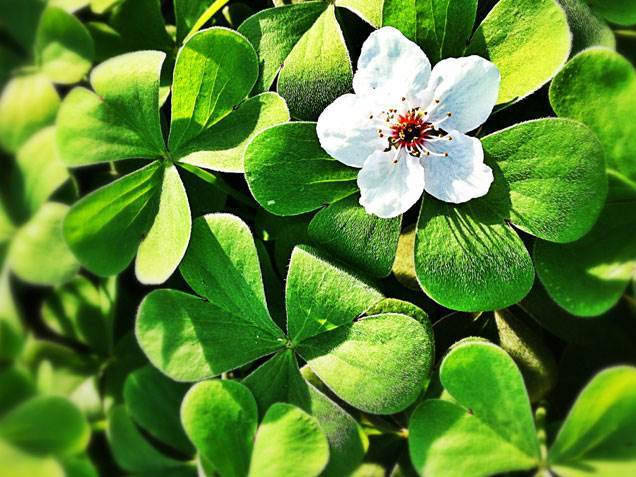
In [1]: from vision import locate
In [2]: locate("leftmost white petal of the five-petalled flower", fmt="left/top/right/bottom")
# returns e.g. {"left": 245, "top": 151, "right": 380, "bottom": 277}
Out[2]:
{"left": 316, "top": 94, "right": 386, "bottom": 167}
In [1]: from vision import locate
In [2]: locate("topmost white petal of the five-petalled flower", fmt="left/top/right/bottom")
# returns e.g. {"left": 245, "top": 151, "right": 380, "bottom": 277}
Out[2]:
{"left": 353, "top": 27, "right": 431, "bottom": 99}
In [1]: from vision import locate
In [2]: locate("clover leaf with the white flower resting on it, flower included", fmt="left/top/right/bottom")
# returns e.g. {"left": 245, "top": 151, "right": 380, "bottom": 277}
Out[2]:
{"left": 245, "top": 23, "right": 607, "bottom": 311}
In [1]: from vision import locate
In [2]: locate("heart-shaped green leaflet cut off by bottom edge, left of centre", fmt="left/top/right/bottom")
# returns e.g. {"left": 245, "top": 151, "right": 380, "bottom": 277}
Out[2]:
{"left": 181, "top": 381, "right": 329, "bottom": 477}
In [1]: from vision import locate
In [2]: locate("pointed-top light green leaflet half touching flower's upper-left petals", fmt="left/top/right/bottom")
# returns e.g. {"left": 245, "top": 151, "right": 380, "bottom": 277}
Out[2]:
{"left": 277, "top": 6, "right": 353, "bottom": 120}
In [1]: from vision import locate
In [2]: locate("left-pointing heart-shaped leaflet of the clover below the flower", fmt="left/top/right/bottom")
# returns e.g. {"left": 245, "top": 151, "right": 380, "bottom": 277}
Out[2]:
{"left": 135, "top": 290, "right": 285, "bottom": 381}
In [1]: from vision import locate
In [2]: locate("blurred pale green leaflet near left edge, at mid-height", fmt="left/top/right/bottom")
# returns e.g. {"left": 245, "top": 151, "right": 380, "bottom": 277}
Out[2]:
{"left": 8, "top": 202, "right": 79, "bottom": 285}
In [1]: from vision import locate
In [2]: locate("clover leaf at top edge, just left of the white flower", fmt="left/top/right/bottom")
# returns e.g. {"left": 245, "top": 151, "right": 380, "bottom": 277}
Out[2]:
{"left": 239, "top": 0, "right": 382, "bottom": 119}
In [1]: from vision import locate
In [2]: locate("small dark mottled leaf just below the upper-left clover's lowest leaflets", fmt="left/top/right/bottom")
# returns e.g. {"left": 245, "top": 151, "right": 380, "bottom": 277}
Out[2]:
{"left": 42, "top": 275, "right": 112, "bottom": 355}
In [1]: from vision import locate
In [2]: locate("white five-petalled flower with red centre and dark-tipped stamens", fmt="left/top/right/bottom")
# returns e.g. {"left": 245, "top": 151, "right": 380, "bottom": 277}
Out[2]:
{"left": 317, "top": 27, "right": 500, "bottom": 218}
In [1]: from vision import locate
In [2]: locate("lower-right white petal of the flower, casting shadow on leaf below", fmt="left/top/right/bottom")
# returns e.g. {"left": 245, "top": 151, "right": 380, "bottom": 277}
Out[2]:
{"left": 421, "top": 131, "right": 493, "bottom": 204}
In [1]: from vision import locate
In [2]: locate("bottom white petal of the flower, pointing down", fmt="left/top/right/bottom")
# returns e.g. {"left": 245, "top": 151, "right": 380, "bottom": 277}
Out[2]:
{"left": 358, "top": 150, "right": 424, "bottom": 219}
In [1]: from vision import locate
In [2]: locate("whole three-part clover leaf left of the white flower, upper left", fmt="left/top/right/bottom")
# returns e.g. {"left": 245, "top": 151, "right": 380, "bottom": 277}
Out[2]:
{"left": 58, "top": 28, "right": 289, "bottom": 283}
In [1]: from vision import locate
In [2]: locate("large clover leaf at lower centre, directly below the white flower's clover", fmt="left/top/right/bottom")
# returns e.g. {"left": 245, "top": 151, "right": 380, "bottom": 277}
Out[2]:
{"left": 136, "top": 214, "right": 432, "bottom": 413}
